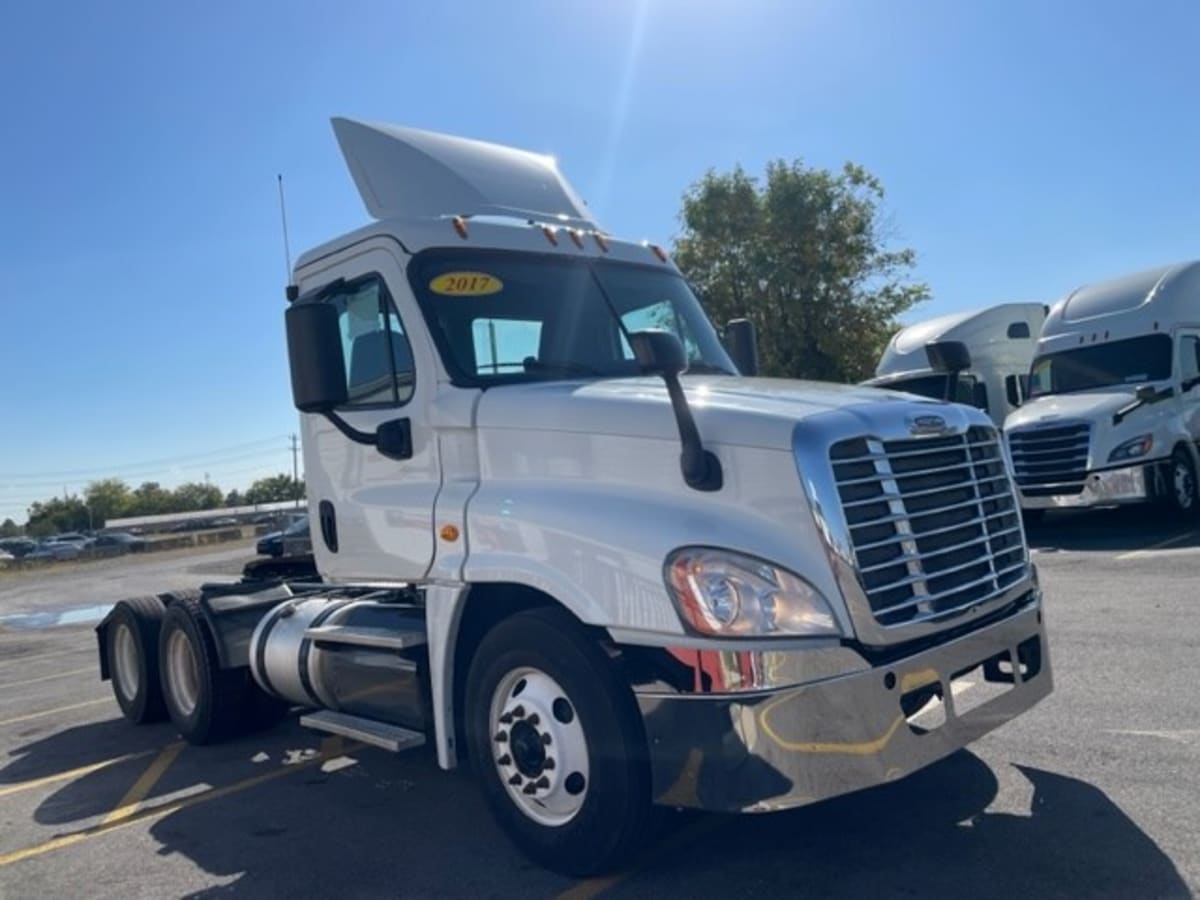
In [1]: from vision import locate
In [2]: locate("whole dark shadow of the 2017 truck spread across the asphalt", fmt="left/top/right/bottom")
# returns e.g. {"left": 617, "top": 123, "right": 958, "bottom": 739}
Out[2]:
{"left": 7, "top": 722, "right": 1189, "bottom": 900}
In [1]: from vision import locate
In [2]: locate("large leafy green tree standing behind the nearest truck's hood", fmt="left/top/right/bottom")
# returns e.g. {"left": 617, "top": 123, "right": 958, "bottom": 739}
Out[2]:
{"left": 674, "top": 160, "right": 929, "bottom": 382}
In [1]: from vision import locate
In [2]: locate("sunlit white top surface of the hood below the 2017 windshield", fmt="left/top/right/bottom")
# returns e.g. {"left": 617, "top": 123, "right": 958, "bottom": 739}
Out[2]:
{"left": 476, "top": 376, "right": 949, "bottom": 450}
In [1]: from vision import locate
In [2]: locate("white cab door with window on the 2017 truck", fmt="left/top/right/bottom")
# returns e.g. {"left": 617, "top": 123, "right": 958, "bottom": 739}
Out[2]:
{"left": 302, "top": 240, "right": 442, "bottom": 581}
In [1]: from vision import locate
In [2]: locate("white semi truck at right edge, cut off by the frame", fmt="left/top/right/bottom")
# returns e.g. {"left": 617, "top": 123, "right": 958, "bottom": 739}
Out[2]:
{"left": 1004, "top": 263, "right": 1200, "bottom": 517}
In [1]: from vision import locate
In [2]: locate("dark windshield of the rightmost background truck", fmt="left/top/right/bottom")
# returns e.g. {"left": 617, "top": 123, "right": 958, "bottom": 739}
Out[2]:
{"left": 1030, "top": 335, "right": 1171, "bottom": 397}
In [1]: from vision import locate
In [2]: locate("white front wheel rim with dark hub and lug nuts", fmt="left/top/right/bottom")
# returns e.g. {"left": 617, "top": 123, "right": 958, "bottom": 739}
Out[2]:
{"left": 488, "top": 667, "right": 592, "bottom": 827}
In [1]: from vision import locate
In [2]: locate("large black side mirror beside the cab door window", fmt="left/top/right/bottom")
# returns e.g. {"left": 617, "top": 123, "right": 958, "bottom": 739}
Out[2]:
{"left": 284, "top": 304, "right": 349, "bottom": 413}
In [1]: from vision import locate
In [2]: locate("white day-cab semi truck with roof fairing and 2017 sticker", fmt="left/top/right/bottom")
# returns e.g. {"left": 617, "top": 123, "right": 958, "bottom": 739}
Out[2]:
{"left": 97, "top": 119, "right": 1051, "bottom": 874}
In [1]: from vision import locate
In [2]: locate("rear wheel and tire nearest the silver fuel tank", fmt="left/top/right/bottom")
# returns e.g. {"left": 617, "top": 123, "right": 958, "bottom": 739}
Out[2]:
{"left": 158, "top": 594, "right": 253, "bottom": 744}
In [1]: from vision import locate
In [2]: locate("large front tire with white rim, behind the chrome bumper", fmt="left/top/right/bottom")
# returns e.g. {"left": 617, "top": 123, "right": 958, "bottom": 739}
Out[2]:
{"left": 466, "top": 608, "right": 652, "bottom": 876}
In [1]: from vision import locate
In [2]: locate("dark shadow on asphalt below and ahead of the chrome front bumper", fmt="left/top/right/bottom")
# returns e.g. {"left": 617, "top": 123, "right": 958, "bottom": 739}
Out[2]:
{"left": 614, "top": 751, "right": 1192, "bottom": 900}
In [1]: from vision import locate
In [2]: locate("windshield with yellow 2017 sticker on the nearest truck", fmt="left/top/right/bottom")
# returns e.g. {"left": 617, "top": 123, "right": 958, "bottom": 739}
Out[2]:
{"left": 409, "top": 251, "right": 737, "bottom": 386}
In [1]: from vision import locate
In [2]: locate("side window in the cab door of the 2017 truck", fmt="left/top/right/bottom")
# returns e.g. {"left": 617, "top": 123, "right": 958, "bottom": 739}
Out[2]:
{"left": 326, "top": 275, "right": 414, "bottom": 406}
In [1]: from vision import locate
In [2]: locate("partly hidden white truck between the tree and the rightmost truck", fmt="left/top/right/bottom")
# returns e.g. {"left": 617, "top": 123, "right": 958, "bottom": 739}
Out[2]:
{"left": 865, "top": 302, "right": 1049, "bottom": 426}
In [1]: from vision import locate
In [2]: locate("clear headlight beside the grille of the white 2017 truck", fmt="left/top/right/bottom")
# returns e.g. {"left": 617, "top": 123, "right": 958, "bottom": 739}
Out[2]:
{"left": 665, "top": 547, "right": 841, "bottom": 637}
